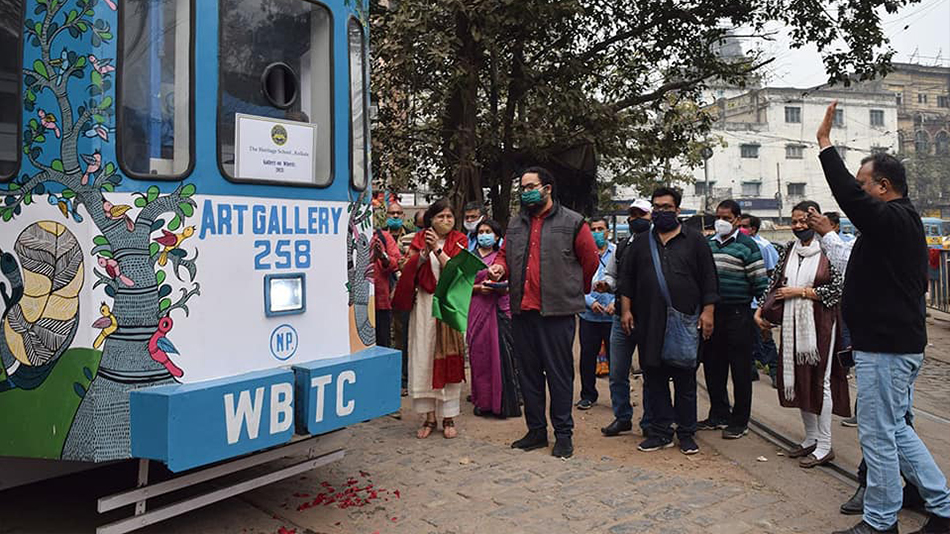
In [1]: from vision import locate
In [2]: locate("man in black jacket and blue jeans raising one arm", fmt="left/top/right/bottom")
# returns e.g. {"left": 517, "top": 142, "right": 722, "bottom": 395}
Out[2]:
{"left": 818, "top": 102, "right": 950, "bottom": 534}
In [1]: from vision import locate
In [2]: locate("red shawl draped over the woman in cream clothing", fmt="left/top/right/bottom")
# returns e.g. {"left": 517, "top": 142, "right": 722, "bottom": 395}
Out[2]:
{"left": 392, "top": 230, "right": 468, "bottom": 389}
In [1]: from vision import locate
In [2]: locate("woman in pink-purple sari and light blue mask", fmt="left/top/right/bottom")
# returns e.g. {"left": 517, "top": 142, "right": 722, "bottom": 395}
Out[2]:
{"left": 465, "top": 219, "right": 521, "bottom": 418}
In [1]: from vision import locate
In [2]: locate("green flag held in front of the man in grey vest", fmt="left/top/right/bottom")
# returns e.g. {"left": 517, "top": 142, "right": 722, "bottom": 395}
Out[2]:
{"left": 432, "top": 250, "right": 485, "bottom": 332}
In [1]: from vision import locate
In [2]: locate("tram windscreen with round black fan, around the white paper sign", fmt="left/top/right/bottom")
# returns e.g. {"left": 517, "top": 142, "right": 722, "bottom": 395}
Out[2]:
{"left": 218, "top": 0, "right": 333, "bottom": 186}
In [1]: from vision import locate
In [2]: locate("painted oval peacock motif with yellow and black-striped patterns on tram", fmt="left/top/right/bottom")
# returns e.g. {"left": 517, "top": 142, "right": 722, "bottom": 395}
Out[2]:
{"left": 0, "top": 221, "right": 84, "bottom": 391}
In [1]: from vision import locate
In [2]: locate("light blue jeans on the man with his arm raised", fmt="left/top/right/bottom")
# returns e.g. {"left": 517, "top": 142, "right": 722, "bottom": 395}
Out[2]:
{"left": 854, "top": 351, "right": 950, "bottom": 530}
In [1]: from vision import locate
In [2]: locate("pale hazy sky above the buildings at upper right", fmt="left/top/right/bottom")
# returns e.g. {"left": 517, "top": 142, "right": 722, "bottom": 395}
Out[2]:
{"left": 747, "top": 0, "right": 950, "bottom": 87}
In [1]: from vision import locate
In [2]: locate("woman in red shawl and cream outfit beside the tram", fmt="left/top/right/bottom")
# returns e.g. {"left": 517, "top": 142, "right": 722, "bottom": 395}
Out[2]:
{"left": 393, "top": 199, "right": 468, "bottom": 439}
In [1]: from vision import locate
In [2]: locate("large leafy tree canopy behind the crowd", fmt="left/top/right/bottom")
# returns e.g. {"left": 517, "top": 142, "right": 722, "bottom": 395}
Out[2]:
{"left": 370, "top": 0, "right": 918, "bottom": 222}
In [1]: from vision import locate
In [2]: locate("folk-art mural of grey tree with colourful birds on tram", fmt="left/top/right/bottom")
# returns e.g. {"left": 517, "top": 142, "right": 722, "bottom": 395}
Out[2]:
{"left": 0, "top": 0, "right": 200, "bottom": 461}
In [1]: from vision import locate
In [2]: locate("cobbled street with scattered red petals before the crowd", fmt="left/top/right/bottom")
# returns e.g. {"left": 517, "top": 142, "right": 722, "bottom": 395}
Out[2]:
{"left": 0, "top": 318, "right": 950, "bottom": 534}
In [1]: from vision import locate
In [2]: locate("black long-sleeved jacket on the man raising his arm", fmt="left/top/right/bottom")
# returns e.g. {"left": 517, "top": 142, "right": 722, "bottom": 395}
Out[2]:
{"left": 819, "top": 149, "right": 927, "bottom": 354}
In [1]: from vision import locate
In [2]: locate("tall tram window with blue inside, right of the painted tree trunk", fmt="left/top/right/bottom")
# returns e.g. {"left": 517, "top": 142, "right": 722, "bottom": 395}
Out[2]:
{"left": 119, "top": 0, "right": 193, "bottom": 178}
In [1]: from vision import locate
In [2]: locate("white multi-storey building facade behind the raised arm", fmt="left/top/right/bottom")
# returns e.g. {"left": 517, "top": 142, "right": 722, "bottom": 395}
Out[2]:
{"left": 680, "top": 88, "right": 898, "bottom": 222}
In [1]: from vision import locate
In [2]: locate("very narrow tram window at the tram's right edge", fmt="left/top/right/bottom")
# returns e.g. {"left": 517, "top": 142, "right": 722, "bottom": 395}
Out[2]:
{"left": 347, "top": 18, "right": 369, "bottom": 189}
